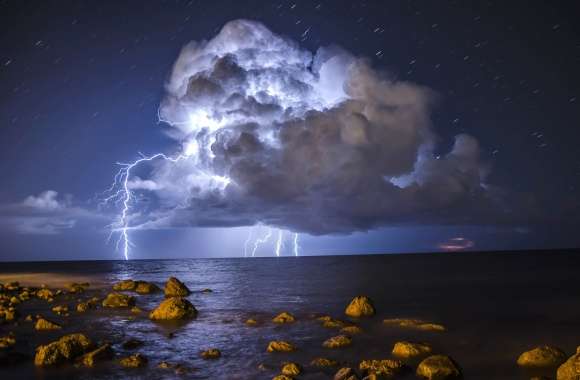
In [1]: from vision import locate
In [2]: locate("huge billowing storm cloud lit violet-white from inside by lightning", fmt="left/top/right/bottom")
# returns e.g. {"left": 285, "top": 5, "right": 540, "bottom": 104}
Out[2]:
{"left": 127, "top": 20, "right": 492, "bottom": 234}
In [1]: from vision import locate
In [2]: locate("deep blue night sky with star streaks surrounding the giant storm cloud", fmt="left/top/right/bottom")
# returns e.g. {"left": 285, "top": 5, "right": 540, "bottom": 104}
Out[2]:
{"left": 0, "top": 0, "right": 580, "bottom": 260}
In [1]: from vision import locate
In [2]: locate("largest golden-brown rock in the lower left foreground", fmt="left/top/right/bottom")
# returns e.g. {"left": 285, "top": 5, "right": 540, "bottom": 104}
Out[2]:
{"left": 34, "top": 334, "right": 93, "bottom": 367}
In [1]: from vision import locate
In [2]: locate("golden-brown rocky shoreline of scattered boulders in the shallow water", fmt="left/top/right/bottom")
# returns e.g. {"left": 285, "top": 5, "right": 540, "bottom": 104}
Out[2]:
{"left": 0, "top": 277, "right": 580, "bottom": 380}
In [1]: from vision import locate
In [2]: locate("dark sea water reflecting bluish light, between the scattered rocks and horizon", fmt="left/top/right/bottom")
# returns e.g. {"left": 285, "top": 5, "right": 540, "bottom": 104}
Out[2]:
{"left": 0, "top": 251, "right": 580, "bottom": 380}
